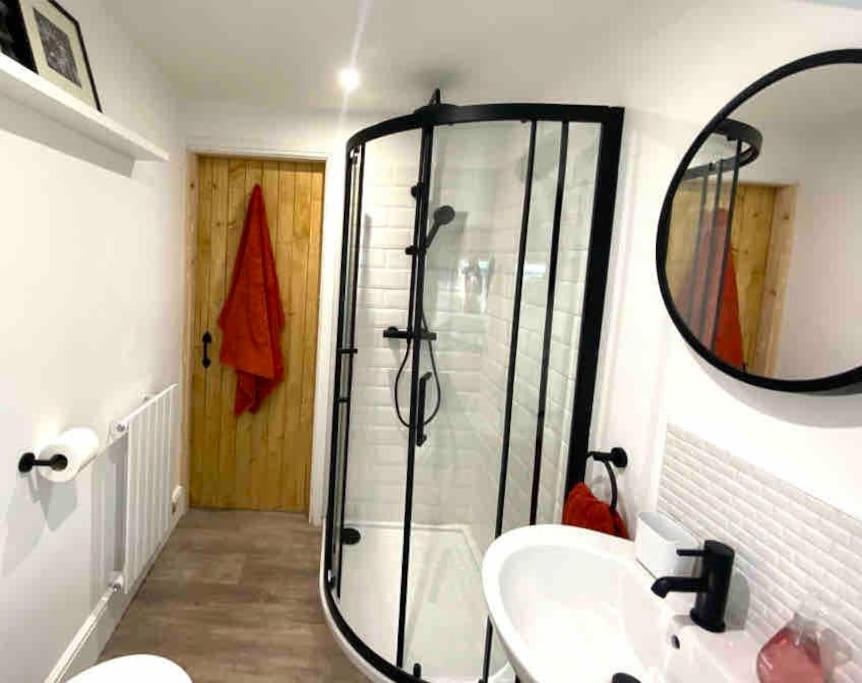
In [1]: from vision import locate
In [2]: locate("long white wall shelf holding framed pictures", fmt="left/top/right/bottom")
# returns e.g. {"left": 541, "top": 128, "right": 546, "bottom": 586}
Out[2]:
{"left": 0, "top": 54, "right": 169, "bottom": 161}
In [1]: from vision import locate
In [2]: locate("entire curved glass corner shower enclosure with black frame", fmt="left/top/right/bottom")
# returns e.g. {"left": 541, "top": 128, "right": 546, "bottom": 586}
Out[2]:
{"left": 322, "top": 97, "right": 622, "bottom": 683}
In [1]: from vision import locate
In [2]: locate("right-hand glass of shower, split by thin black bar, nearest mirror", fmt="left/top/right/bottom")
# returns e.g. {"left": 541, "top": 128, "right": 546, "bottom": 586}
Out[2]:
{"left": 490, "top": 122, "right": 599, "bottom": 672}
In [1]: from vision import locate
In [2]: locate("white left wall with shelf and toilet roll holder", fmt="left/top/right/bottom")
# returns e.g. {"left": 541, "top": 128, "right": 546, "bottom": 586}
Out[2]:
{"left": 0, "top": 0, "right": 184, "bottom": 683}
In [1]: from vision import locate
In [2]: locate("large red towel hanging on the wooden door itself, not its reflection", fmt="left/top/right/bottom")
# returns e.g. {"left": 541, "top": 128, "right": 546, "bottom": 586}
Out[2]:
{"left": 218, "top": 185, "right": 284, "bottom": 415}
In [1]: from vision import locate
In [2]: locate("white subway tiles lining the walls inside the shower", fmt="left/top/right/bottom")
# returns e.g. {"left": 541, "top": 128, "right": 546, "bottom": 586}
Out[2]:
{"left": 347, "top": 124, "right": 594, "bottom": 572}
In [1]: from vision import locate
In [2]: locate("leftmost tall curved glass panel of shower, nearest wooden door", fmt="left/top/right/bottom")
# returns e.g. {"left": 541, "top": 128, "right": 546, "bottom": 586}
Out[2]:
{"left": 339, "top": 131, "right": 420, "bottom": 662}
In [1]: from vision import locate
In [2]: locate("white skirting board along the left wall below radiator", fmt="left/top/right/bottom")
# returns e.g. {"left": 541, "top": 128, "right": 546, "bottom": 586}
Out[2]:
{"left": 45, "top": 486, "right": 188, "bottom": 683}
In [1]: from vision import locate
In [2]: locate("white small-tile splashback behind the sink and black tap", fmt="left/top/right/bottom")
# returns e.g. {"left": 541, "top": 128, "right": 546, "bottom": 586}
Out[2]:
{"left": 658, "top": 426, "right": 862, "bottom": 682}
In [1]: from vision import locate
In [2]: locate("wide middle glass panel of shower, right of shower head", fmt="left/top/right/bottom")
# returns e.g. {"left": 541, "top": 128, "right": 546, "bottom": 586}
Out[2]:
{"left": 404, "top": 122, "right": 530, "bottom": 680}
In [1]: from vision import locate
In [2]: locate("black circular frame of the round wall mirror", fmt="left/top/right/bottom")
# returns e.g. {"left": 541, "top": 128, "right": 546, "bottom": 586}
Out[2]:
{"left": 656, "top": 48, "right": 862, "bottom": 394}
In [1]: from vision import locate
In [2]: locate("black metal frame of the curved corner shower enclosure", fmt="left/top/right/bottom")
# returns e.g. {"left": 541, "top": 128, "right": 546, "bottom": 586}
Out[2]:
{"left": 321, "top": 99, "right": 624, "bottom": 683}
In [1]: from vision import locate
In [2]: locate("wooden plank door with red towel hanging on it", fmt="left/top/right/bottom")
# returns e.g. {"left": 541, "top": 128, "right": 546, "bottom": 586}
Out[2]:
{"left": 189, "top": 156, "right": 324, "bottom": 511}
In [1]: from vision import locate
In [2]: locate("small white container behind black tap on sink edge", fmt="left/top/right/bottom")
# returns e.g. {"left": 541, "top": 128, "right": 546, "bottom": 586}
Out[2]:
{"left": 635, "top": 512, "right": 700, "bottom": 578}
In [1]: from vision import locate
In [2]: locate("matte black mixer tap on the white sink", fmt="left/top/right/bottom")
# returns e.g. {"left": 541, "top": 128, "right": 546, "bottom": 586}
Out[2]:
{"left": 652, "top": 541, "right": 734, "bottom": 633}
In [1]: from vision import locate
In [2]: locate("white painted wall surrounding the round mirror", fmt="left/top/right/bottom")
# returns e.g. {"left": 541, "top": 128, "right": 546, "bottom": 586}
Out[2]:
{"left": 568, "top": 0, "right": 862, "bottom": 528}
